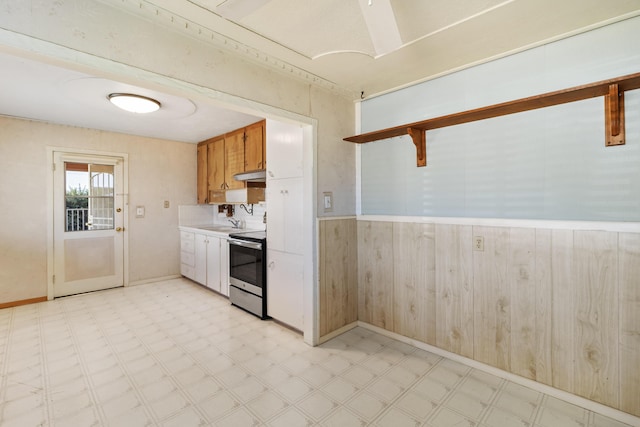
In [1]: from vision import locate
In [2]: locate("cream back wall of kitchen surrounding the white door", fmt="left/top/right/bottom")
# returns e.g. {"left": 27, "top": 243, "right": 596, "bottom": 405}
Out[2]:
{"left": 0, "top": 117, "right": 196, "bottom": 303}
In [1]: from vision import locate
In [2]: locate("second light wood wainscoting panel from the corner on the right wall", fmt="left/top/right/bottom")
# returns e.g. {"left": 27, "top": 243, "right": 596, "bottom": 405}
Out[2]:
{"left": 393, "top": 222, "right": 436, "bottom": 345}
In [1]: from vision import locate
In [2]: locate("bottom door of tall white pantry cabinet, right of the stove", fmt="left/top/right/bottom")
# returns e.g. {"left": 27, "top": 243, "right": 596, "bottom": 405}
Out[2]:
{"left": 267, "top": 249, "right": 304, "bottom": 330}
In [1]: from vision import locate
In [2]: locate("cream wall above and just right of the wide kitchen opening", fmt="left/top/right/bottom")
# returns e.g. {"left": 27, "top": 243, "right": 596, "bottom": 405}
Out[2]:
{"left": 0, "top": 0, "right": 355, "bottom": 216}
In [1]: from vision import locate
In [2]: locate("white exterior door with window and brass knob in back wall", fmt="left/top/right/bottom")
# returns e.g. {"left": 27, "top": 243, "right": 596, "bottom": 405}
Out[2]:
{"left": 53, "top": 152, "right": 125, "bottom": 297}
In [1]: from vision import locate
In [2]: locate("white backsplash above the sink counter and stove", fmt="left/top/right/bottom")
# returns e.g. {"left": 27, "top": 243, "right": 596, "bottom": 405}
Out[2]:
{"left": 178, "top": 203, "right": 266, "bottom": 230}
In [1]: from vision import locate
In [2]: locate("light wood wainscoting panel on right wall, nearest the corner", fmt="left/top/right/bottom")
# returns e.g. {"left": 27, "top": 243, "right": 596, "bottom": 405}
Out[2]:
{"left": 358, "top": 221, "right": 394, "bottom": 331}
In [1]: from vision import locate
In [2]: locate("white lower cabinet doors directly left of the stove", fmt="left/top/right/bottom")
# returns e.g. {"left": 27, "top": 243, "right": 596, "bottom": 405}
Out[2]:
{"left": 187, "top": 233, "right": 229, "bottom": 296}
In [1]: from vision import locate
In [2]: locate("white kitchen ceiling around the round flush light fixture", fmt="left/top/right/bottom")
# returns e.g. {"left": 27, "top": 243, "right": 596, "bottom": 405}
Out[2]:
{"left": 0, "top": 52, "right": 261, "bottom": 142}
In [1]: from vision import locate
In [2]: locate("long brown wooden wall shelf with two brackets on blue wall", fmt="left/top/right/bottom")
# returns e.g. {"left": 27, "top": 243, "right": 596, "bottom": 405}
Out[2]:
{"left": 344, "top": 73, "right": 640, "bottom": 166}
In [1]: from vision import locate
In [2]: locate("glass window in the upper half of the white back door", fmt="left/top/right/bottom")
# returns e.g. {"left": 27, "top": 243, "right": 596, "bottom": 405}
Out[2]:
{"left": 64, "top": 162, "right": 115, "bottom": 231}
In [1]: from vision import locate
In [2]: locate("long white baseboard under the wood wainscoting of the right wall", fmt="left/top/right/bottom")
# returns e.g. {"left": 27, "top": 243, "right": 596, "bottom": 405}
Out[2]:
{"left": 360, "top": 321, "right": 640, "bottom": 427}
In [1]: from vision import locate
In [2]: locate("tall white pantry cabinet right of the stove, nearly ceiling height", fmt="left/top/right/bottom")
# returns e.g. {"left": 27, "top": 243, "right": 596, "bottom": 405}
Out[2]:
{"left": 266, "top": 120, "right": 304, "bottom": 330}
